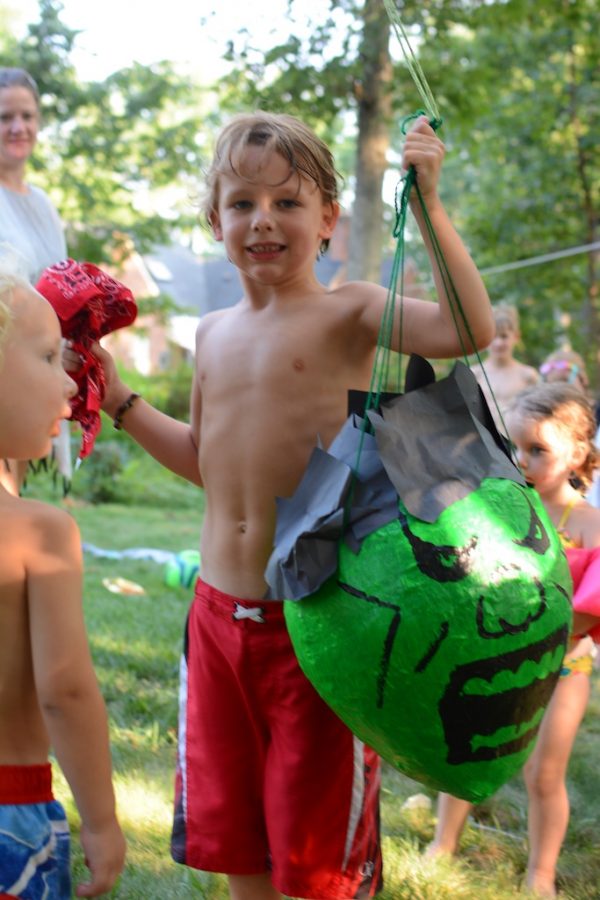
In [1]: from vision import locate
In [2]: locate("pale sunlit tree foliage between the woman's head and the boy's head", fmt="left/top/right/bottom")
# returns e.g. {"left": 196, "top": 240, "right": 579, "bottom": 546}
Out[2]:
{"left": 0, "top": 0, "right": 209, "bottom": 262}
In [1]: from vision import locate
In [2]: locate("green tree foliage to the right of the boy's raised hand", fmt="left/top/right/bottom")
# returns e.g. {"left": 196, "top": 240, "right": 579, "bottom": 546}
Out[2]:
{"left": 422, "top": 0, "right": 600, "bottom": 380}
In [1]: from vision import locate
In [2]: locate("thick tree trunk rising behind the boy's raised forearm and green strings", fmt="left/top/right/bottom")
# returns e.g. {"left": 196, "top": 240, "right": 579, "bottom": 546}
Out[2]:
{"left": 347, "top": 0, "right": 392, "bottom": 283}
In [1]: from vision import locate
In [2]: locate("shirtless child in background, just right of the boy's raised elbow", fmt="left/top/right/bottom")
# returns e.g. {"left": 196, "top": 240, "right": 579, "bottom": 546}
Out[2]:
{"left": 471, "top": 303, "right": 539, "bottom": 432}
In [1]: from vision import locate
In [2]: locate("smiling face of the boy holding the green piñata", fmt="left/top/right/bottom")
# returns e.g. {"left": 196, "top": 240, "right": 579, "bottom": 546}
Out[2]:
{"left": 211, "top": 146, "right": 339, "bottom": 284}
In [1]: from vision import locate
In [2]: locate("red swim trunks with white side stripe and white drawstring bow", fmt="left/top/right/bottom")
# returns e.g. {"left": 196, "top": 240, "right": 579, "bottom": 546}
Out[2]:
{"left": 171, "top": 581, "right": 382, "bottom": 900}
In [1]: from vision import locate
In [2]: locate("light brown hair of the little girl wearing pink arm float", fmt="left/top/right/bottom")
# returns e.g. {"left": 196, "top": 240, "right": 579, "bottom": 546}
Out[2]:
{"left": 508, "top": 381, "right": 600, "bottom": 492}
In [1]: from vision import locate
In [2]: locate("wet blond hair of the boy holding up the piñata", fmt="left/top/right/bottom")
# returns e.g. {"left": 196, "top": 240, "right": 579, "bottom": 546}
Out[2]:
{"left": 202, "top": 111, "right": 339, "bottom": 252}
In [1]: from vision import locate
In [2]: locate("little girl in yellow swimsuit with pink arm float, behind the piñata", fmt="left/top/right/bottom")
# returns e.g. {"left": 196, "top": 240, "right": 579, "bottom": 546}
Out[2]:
{"left": 427, "top": 382, "right": 600, "bottom": 897}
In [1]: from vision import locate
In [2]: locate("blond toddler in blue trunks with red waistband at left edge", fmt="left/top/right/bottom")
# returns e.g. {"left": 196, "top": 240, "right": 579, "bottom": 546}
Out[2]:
{"left": 0, "top": 261, "right": 125, "bottom": 900}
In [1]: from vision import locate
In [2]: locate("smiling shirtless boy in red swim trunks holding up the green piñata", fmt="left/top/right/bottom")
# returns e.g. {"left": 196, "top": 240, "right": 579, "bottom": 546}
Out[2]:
{"left": 97, "top": 113, "right": 493, "bottom": 900}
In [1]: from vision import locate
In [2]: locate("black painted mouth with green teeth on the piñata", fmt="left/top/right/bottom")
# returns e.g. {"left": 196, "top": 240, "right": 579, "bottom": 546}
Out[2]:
{"left": 438, "top": 625, "right": 568, "bottom": 765}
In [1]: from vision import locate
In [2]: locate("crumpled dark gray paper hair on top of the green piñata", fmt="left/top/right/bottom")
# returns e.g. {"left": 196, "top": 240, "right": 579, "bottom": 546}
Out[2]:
{"left": 265, "top": 361, "right": 525, "bottom": 600}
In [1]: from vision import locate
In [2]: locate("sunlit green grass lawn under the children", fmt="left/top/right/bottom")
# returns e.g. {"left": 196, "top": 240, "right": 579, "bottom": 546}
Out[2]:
{"left": 42, "top": 487, "right": 600, "bottom": 900}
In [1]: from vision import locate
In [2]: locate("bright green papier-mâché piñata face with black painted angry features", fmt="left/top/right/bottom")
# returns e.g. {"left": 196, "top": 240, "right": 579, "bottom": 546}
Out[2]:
{"left": 285, "top": 478, "right": 571, "bottom": 802}
